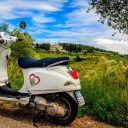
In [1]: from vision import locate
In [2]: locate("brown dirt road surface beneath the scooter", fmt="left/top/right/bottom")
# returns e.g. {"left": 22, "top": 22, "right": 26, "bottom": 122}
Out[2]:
{"left": 0, "top": 108, "right": 116, "bottom": 128}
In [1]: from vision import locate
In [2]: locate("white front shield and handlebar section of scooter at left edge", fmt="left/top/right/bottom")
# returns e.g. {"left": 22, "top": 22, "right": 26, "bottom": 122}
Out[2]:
{"left": 0, "top": 32, "right": 17, "bottom": 86}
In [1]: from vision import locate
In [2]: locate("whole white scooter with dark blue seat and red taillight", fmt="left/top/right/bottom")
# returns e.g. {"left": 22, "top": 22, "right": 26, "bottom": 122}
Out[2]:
{"left": 0, "top": 21, "right": 85, "bottom": 125}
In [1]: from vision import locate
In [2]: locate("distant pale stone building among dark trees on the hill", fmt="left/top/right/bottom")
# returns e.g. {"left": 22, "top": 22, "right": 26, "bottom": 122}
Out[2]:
{"left": 50, "top": 44, "right": 66, "bottom": 52}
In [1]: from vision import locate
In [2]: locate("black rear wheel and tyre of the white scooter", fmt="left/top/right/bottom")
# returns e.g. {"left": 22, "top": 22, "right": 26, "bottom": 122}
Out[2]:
{"left": 48, "top": 93, "right": 78, "bottom": 125}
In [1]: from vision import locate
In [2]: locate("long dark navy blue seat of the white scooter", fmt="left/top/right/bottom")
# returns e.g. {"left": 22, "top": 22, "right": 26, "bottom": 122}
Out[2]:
{"left": 18, "top": 57, "right": 69, "bottom": 69}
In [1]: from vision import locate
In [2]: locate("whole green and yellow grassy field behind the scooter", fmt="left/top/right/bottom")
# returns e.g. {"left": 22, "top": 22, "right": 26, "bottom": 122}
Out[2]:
{"left": 8, "top": 50, "right": 128, "bottom": 128}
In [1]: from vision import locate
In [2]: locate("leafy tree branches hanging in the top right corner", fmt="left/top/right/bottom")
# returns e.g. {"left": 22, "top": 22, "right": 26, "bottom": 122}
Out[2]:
{"left": 88, "top": 0, "right": 128, "bottom": 34}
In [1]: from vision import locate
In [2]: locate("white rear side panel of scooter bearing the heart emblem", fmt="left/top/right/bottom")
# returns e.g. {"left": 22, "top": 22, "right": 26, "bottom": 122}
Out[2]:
{"left": 19, "top": 66, "right": 81, "bottom": 95}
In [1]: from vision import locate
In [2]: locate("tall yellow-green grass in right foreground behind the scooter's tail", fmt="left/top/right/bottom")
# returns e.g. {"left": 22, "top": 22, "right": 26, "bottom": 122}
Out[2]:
{"left": 74, "top": 57, "right": 128, "bottom": 128}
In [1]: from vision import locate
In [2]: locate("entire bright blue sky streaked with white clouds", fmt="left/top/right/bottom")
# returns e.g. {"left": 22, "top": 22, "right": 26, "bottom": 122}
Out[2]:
{"left": 0, "top": 0, "right": 128, "bottom": 54}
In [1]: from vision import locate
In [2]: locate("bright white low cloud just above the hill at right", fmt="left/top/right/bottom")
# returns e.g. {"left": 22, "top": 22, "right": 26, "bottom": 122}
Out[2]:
{"left": 93, "top": 38, "right": 128, "bottom": 54}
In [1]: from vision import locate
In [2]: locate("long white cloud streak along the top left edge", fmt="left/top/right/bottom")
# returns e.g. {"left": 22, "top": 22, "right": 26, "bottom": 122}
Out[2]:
{"left": 0, "top": 0, "right": 64, "bottom": 12}
